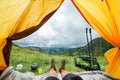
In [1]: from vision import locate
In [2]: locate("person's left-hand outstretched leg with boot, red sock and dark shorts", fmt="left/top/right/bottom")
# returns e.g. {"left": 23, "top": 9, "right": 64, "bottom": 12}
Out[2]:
{"left": 45, "top": 59, "right": 59, "bottom": 80}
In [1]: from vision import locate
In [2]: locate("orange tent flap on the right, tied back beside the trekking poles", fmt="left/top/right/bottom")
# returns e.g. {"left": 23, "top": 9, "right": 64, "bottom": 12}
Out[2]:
{"left": 72, "top": 0, "right": 120, "bottom": 79}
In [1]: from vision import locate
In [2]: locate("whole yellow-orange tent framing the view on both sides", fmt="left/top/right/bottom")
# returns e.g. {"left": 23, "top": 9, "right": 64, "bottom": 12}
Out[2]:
{"left": 0, "top": 0, "right": 120, "bottom": 79}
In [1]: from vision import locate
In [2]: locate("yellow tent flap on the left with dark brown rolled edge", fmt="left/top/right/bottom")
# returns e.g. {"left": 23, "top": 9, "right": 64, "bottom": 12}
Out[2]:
{"left": 0, "top": 0, "right": 63, "bottom": 70}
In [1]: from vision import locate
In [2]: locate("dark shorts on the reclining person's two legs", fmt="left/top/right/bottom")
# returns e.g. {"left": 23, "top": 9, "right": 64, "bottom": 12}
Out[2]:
{"left": 45, "top": 73, "right": 83, "bottom": 80}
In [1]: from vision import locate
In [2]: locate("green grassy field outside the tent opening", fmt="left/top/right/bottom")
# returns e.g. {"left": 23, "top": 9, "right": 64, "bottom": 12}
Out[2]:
{"left": 10, "top": 46, "right": 107, "bottom": 74}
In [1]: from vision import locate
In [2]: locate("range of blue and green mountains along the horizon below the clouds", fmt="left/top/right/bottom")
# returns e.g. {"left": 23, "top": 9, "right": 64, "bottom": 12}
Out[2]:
{"left": 13, "top": 37, "right": 113, "bottom": 56}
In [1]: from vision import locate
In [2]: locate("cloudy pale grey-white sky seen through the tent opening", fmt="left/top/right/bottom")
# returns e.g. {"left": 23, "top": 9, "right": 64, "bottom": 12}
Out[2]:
{"left": 14, "top": 0, "right": 99, "bottom": 47}
